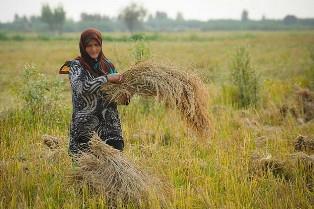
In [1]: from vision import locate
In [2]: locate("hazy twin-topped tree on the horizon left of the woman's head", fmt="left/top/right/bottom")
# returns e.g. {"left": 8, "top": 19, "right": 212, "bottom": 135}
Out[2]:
{"left": 41, "top": 4, "right": 65, "bottom": 33}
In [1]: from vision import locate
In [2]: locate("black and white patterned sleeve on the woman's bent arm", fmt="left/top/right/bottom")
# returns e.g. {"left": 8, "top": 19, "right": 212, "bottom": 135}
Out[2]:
{"left": 69, "top": 61, "right": 108, "bottom": 94}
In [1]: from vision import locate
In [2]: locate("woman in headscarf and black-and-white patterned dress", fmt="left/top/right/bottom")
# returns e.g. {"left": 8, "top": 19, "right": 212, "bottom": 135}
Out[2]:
{"left": 60, "top": 28, "right": 129, "bottom": 156}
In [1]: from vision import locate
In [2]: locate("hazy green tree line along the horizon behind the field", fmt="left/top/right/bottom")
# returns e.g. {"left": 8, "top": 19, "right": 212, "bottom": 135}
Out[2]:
{"left": 0, "top": 3, "right": 314, "bottom": 34}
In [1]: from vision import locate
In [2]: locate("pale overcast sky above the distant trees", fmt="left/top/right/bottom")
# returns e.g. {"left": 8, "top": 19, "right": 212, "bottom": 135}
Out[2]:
{"left": 0, "top": 0, "right": 314, "bottom": 22}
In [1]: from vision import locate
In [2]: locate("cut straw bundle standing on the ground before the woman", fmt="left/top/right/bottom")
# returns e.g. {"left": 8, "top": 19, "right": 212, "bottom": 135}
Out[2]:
{"left": 70, "top": 134, "right": 169, "bottom": 208}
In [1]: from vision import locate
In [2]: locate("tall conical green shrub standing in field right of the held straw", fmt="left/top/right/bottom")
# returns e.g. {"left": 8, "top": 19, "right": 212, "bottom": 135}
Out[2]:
{"left": 230, "top": 47, "right": 259, "bottom": 108}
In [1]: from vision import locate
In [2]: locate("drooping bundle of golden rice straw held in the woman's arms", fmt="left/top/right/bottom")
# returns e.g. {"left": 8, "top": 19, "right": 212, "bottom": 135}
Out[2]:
{"left": 101, "top": 61, "right": 210, "bottom": 135}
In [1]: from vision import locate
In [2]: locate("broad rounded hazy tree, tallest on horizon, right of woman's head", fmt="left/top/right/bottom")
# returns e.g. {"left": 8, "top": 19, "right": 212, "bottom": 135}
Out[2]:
{"left": 118, "top": 3, "right": 147, "bottom": 33}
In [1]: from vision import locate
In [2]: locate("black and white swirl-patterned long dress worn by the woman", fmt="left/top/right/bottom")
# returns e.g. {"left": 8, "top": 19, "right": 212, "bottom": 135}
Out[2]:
{"left": 69, "top": 60, "right": 124, "bottom": 155}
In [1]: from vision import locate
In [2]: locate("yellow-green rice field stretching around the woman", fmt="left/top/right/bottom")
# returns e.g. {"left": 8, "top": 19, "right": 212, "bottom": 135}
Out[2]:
{"left": 0, "top": 31, "right": 314, "bottom": 209}
